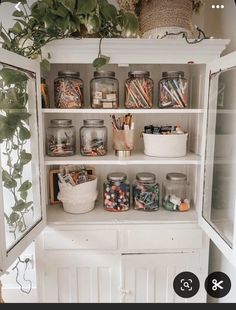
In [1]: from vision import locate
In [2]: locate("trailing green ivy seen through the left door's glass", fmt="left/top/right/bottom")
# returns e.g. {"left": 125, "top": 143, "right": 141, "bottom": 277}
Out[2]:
{"left": 0, "top": 66, "right": 33, "bottom": 240}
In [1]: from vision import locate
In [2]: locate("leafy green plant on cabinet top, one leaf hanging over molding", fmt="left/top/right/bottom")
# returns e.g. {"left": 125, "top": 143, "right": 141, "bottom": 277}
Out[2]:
{"left": 0, "top": 0, "right": 138, "bottom": 69}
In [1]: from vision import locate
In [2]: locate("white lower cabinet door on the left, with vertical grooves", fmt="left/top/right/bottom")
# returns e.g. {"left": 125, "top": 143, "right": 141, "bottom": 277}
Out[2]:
{"left": 40, "top": 251, "right": 120, "bottom": 303}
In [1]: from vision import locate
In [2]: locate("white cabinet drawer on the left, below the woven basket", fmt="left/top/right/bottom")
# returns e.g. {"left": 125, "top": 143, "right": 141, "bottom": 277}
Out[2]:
{"left": 43, "top": 230, "right": 118, "bottom": 250}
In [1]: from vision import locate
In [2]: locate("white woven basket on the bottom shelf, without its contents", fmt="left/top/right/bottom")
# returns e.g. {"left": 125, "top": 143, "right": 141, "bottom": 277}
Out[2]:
{"left": 57, "top": 176, "right": 98, "bottom": 214}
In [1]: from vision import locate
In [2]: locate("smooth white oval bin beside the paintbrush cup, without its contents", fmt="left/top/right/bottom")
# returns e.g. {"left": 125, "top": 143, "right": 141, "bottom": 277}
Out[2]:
{"left": 143, "top": 133, "right": 188, "bottom": 157}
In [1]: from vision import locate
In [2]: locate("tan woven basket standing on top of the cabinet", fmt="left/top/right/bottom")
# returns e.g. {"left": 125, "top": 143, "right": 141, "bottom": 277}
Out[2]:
{"left": 140, "top": 0, "right": 193, "bottom": 37}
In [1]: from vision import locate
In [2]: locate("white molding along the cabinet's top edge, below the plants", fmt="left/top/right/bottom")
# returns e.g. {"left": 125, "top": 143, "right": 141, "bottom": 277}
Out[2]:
{"left": 43, "top": 39, "right": 230, "bottom": 65}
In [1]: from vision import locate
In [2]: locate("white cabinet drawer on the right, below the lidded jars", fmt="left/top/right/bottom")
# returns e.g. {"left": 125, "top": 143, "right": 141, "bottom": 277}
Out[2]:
{"left": 127, "top": 228, "right": 203, "bottom": 250}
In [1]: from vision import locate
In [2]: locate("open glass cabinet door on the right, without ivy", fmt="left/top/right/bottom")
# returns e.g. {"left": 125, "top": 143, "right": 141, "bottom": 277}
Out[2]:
{"left": 200, "top": 52, "right": 236, "bottom": 266}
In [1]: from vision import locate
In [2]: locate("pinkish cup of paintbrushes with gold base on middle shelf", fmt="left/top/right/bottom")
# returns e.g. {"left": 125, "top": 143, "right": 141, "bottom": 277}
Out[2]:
{"left": 111, "top": 113, "right": 134, "bottom": 157}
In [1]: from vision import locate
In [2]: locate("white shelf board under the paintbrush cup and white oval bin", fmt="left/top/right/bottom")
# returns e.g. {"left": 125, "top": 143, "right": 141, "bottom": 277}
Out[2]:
{"left": 44, "top": 152, "right": 200, "bottom": 166}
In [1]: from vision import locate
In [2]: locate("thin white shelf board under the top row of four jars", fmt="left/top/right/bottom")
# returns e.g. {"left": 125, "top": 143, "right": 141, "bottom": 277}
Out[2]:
{"left": 42, "top": 108, "right": 204, "bottom": 114}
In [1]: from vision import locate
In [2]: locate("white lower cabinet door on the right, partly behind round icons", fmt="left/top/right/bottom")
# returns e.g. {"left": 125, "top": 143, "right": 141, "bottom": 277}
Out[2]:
{"left": 122, "top": 252, "right": 206, "bottom": 303}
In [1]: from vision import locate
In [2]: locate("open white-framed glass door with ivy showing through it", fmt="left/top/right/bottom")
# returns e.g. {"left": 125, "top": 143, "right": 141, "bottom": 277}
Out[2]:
{"left": 0, "top": 48, "right": 46, "bottom": 274}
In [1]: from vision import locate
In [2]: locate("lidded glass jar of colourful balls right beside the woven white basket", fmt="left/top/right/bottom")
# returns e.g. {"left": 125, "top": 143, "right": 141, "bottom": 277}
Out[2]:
{"left": 103, "top": 172, "right": 130, "bottom": 212}
